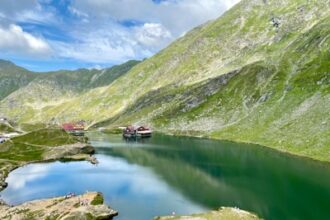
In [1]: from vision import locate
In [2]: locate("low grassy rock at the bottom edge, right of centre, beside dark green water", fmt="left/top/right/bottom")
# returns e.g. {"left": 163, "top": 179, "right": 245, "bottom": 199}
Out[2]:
{"left": 155, "top": 207, "right": 259, "bottom": 220}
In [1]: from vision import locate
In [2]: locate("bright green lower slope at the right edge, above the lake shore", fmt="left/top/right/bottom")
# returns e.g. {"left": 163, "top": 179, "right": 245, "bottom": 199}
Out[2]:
{"left": 211, "top": 17, "right": 330, "bottom": 161}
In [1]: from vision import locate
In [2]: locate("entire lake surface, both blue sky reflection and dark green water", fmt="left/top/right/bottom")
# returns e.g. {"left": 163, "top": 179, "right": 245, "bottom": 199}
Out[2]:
{"left": 0, "top": 132, "right": 330, "bottom": 220}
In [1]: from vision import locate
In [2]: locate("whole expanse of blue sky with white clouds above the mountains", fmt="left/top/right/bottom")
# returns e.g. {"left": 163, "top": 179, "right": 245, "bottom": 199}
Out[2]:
{"left": 0, "top": 0, "right": 239, "bottom": 71}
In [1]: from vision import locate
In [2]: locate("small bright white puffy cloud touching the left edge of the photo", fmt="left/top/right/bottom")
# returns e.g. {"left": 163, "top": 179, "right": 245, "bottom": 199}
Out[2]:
{"left": 0, "top": 24, "right": 51, "bottom": 56}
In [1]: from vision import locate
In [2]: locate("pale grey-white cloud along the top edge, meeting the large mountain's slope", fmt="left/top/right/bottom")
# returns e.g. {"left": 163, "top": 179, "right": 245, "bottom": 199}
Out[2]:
{"left": 72, "top": 0, "right": 239, "bottom": 36}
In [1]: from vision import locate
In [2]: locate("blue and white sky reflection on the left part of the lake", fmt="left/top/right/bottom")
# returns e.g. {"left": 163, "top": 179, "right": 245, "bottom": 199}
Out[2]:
{"left": 1, "top": 155, "right": 205, "bottom": 220}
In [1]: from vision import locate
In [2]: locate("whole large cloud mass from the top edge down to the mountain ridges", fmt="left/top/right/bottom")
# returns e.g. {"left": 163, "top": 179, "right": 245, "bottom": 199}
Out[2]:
{"left": 54, "top": 0, "right": 239, "bottom": 63}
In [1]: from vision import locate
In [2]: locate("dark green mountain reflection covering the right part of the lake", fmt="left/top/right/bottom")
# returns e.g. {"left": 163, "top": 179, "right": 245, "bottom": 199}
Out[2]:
{"left": 91, "top": 132, "right": 330, "bottom": 219}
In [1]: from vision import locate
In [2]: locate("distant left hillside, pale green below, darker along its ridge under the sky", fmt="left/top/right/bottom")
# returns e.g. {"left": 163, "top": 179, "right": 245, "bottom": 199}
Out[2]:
{"left": 0, "top": 61, "right": 139, "bottom": 122}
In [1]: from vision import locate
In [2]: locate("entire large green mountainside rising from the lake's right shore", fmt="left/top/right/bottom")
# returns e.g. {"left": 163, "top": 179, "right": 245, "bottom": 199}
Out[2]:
{"left": 0, "top": 0, "right": 330, "bottom": 161}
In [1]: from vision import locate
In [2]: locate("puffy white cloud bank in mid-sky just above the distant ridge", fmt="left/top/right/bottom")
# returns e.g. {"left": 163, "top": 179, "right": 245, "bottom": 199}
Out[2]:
{"left": 52, "top": 21, "right": 172, "bottom": 64}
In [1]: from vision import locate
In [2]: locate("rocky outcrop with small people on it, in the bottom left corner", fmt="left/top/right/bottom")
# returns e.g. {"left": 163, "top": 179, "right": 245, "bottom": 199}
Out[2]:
{"left": 0, "top": 192, "right": 118, "bottom": 220}
